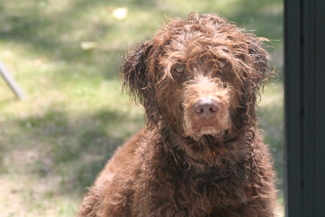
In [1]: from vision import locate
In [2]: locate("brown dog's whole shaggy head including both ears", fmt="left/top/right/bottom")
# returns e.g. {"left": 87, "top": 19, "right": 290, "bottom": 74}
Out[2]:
{"left": 121, "top": 14, "right": 271, "bottom": 137}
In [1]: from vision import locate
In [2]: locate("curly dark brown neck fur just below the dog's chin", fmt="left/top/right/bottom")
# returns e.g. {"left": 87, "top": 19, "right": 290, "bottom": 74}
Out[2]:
{"left": 155, "top": 122, "right": 255, "bottom": 172}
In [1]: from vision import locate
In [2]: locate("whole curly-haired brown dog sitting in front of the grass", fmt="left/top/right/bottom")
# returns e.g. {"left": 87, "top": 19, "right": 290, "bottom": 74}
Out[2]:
{"left": 79, "top": 14, "right": 277, "bottom": 217}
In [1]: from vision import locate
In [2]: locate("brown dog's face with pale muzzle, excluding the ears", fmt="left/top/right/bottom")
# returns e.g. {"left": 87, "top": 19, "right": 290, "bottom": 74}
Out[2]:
{"left": 157, "top": 38, "right": 234, "bottom": 137}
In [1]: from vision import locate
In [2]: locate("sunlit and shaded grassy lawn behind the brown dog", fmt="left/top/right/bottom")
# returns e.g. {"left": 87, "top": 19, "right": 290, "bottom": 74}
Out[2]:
{"left": 0, "top": 0, "right": 283, "bottom": 217}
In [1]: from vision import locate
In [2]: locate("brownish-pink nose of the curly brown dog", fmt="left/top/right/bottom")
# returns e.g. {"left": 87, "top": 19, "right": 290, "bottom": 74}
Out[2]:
{"left": 194, "top": 99, "right": 219, "bottom": 119}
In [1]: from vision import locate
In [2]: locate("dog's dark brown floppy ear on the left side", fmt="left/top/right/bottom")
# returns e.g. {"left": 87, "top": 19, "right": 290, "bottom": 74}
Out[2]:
{"left": 120, "top": 40, "right": 159, "bottom": 124}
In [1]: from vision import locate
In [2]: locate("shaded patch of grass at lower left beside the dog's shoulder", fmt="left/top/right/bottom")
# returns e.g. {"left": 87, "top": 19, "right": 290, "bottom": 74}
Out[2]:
{"left": 0, "top": 107, "right": 143, "bottom": 194}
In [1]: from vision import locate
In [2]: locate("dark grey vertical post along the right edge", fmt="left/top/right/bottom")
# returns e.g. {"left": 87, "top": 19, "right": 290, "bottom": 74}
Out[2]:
{"left": 285, "top": 0, "right": 325, "bottom": 217}
